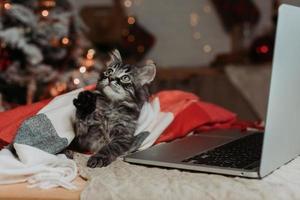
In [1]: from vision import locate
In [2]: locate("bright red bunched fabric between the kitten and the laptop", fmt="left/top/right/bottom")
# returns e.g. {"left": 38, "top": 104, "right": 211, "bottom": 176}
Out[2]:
{"left": 155, "top": 91, "right": 237, "bottom": 143}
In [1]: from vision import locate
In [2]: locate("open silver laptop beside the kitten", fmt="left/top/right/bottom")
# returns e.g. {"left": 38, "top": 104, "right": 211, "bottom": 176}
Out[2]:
{"left": 124, "top": 5, "right": 300, "bottom": 178}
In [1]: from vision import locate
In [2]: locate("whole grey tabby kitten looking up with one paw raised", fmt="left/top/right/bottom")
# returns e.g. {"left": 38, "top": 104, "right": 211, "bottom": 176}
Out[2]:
{"left": 71, "top": 50, "right": 156, "bottom": 168}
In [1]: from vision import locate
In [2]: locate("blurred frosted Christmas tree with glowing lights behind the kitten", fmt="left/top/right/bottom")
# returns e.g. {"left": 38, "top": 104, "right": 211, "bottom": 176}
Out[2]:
{"left": 0, "top": 0, "right": 101, "bottom": 103}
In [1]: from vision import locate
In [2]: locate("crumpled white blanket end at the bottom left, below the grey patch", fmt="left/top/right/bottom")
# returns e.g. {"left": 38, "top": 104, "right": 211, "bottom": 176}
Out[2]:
{"left": 0, "top": 143, "right": 77, "bottom": 189}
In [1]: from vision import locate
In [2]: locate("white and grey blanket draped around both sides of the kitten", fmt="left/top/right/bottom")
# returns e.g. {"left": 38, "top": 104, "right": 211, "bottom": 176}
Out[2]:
{"left": 0, "top": 89, "right": 174, "bottom": 189}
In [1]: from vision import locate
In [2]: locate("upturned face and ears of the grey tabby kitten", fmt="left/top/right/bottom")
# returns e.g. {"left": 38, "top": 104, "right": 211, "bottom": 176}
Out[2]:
{"left": 97, "top": 50, "right": 156, "bottom": 101}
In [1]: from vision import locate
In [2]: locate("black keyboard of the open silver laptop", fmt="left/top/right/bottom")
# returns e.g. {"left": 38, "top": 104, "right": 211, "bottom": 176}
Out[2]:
{"left": 183, "top": 133, "right": 263, "bottom": 169}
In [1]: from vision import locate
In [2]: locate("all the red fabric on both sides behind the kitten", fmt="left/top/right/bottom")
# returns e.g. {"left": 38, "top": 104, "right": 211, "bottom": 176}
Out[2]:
{"left": 0, "top": 85, "right": 262, "bottom": 149}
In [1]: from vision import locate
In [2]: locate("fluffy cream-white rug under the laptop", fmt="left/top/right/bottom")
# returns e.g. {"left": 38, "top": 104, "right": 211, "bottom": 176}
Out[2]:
{"left": 75, "top": 154, "right": 300, "bottom": 200}
